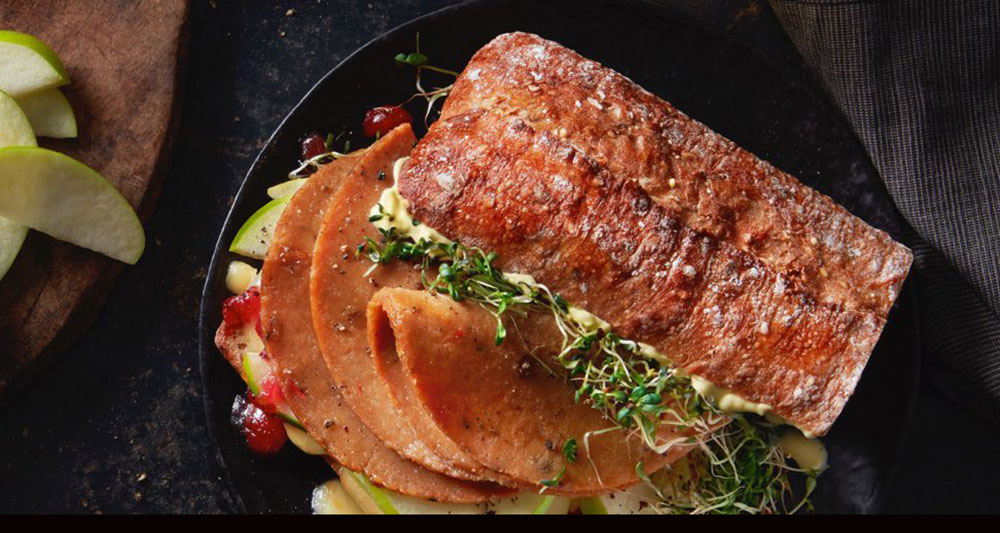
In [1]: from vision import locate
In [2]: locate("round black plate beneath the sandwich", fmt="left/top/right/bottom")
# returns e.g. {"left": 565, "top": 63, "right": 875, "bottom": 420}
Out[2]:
{"left": 201, "top": 0, "right": 918, "bottom": 512}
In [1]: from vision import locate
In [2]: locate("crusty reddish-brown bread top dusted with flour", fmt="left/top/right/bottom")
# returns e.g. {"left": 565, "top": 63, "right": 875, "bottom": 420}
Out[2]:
{"left": 398, "top": 33, "right": 912, "bottom": 435}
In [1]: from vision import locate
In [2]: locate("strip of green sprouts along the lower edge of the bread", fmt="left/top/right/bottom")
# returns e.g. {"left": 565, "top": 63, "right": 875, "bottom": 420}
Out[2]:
{"left": 357, "top": 228, "right": 816, "bottom": 514}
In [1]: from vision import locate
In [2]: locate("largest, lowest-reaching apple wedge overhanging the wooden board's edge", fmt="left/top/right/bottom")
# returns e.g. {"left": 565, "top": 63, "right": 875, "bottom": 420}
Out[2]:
{"left": 0, "top": 146, "right": 146, "bottom": 264}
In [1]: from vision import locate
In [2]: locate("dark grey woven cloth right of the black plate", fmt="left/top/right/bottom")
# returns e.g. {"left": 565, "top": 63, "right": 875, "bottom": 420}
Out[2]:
{"left": 771, "top": 0, "right": 1000, "bottom": 422}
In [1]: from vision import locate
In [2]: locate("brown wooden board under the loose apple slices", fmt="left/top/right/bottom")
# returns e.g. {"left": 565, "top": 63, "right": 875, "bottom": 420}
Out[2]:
{"left": 0, "top": 0, "right": 188, "bottom": 400}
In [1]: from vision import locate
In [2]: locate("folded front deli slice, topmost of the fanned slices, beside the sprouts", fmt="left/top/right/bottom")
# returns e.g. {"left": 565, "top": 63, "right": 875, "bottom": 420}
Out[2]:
{"left": 368, "top": 288, "right": 688, "bottom": 495}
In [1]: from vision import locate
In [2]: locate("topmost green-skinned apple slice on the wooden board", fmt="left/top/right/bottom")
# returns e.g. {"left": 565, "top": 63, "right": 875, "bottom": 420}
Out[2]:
{"left": 0, "top": 31, "right": 69, "bottom": 98}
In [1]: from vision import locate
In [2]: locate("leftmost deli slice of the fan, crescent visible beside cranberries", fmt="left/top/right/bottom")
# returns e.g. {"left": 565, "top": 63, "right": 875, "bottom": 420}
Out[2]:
{"left": 258, "top": 144, "right": 508, "bottom": 502}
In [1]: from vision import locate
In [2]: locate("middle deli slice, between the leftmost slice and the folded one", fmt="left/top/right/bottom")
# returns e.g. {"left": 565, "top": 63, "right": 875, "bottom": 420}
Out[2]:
{"left": 308, "top": 125, "right": 512, "bottom": 489}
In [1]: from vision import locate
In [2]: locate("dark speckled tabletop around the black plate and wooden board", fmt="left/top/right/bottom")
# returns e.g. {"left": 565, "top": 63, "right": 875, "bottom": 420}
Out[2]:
{"left": 0, "top": 0, "right": 1000, "bottom": 513}
